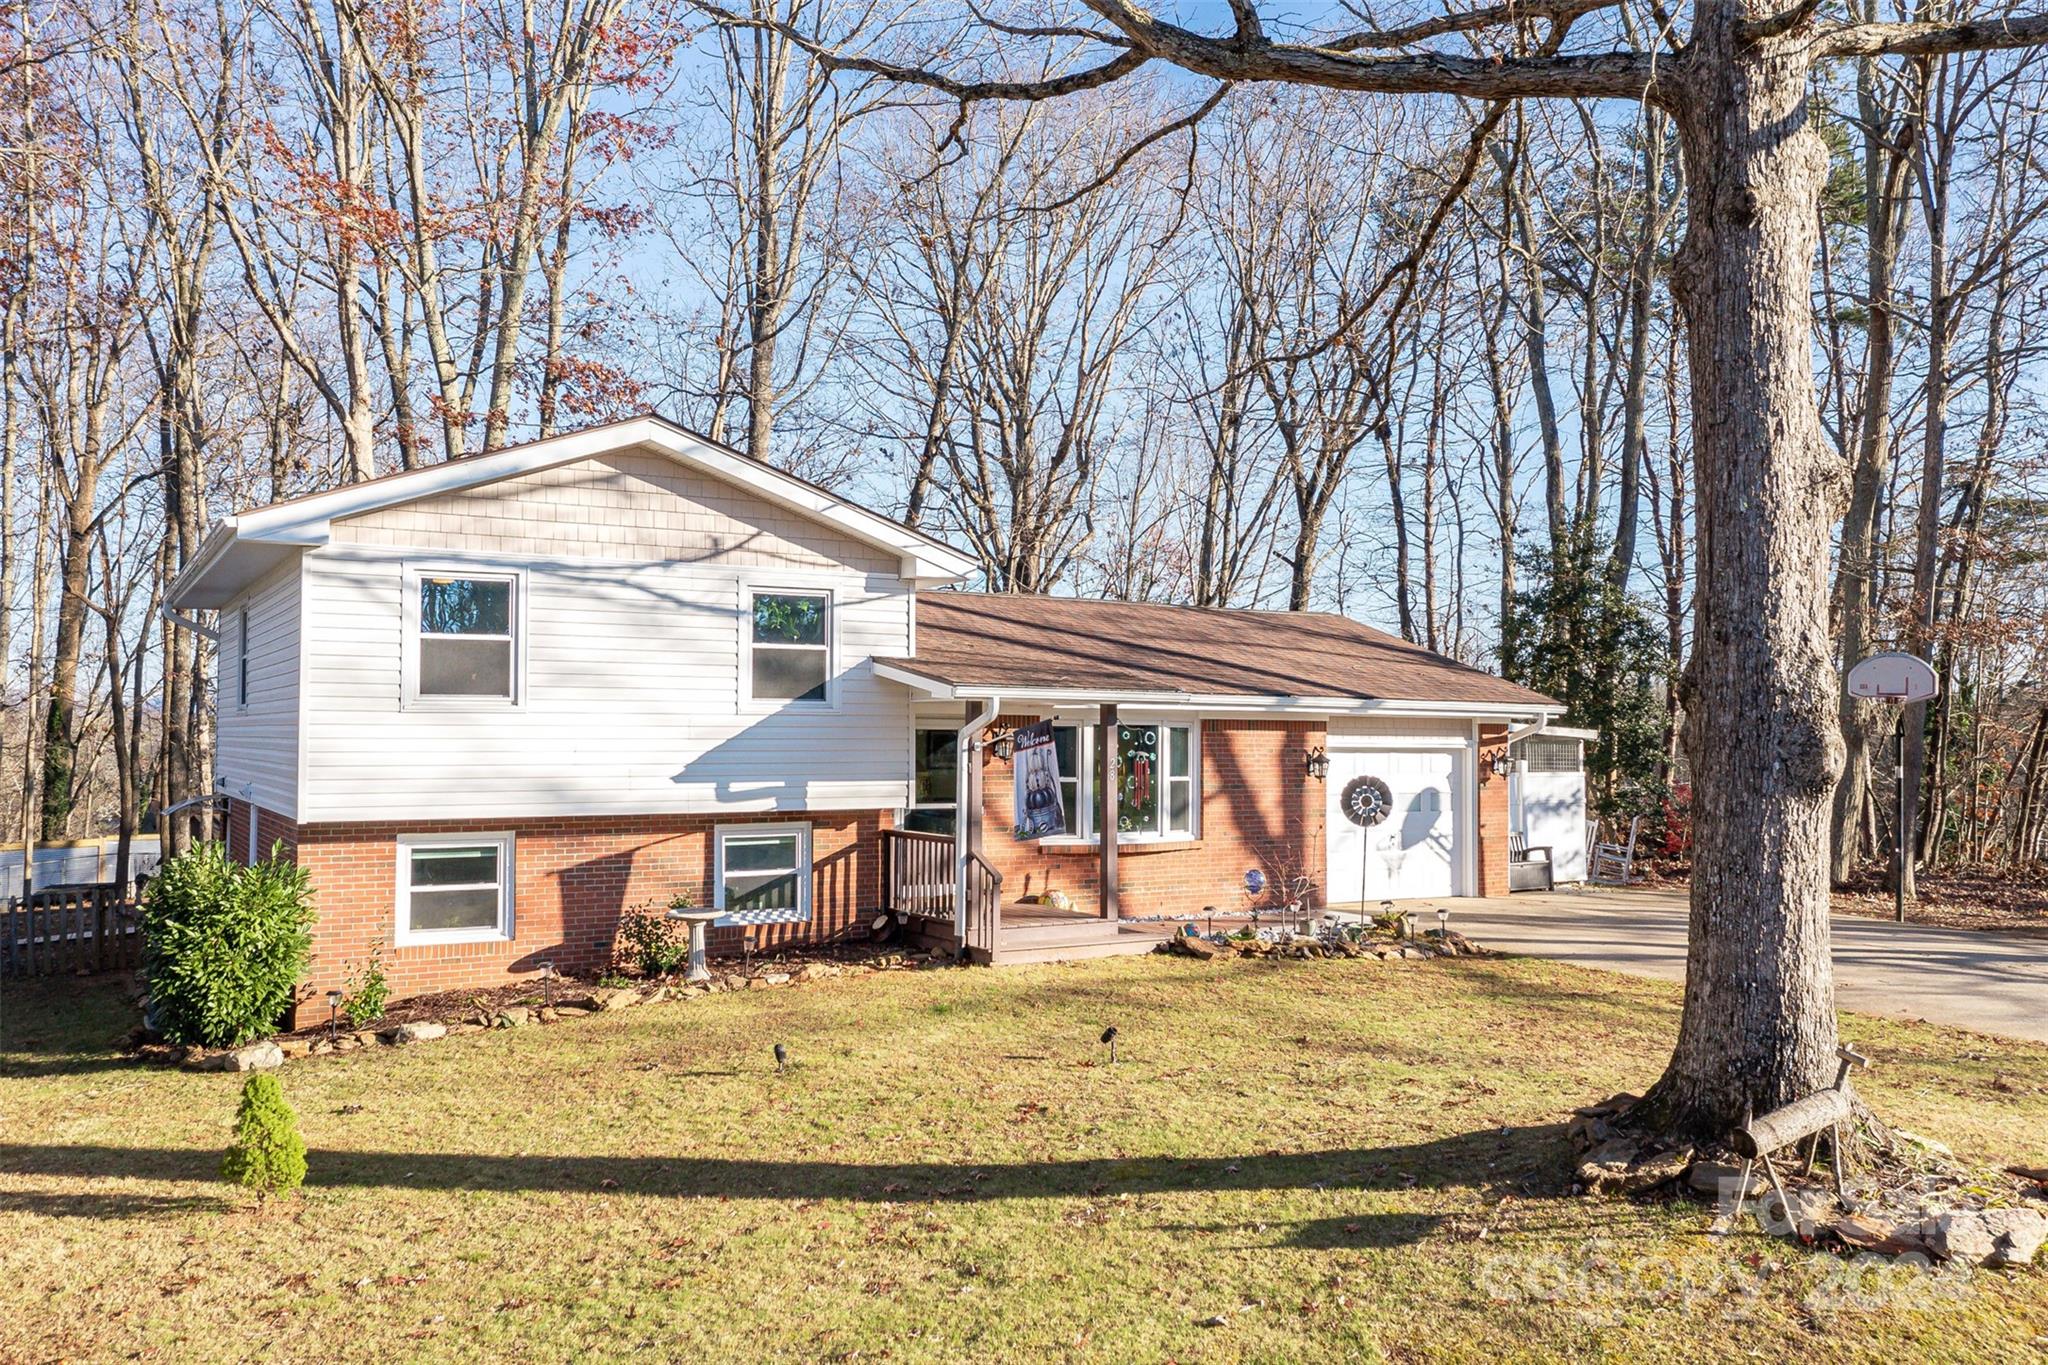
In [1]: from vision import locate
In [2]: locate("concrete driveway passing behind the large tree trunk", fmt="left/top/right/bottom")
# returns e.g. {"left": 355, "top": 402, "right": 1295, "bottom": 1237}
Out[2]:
{"left": 1441, "top": 888, "right": 2048, "bottom": 1042}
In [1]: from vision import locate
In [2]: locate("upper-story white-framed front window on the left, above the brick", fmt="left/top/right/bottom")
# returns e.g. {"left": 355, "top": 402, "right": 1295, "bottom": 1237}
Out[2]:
{"left": 406, "top": 569, "right": 522, "bottom": 704}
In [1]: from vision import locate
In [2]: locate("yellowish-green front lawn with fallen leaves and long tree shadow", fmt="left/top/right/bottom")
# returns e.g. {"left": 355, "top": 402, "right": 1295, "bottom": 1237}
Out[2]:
{"left": 0, "top": 958, "right": 2048, "bottom": 1361}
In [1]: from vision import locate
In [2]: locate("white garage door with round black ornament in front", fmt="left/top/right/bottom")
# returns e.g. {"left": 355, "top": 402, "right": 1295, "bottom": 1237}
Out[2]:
{"left": 1325, "top": 749, "right": 1464, "bottom": 905}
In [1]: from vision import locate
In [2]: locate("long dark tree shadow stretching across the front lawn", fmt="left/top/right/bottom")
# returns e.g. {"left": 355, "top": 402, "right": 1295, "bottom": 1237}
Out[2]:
{"left": 0, "top": 1124, "right": 1565, "bottom": 1246}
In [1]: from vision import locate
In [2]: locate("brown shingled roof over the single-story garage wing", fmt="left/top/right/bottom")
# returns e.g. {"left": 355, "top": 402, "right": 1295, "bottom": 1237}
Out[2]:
{"left": 885, "top": 591, "right": 1556, "bottom": 708}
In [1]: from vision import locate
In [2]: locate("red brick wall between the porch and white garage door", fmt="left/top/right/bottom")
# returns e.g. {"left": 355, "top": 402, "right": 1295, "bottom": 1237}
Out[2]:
{"left": 981, "top": 716, "right": 1327, "bottom": 915}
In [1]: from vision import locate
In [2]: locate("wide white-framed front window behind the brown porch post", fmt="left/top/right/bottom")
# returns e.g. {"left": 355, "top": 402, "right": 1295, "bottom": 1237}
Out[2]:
{"left": 1053, "top": 720, "right": 1202, "bottom": 843}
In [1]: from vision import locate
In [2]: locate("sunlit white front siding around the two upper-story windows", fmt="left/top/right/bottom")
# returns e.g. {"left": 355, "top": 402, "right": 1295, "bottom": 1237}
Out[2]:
{"left": 303, "top": 544, "right": 909, "bottom": 821}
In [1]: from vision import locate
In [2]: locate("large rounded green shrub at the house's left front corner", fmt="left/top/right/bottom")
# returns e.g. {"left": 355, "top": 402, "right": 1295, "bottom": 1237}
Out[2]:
{"left": 141, "top": 843, "right": 313, "bottom": 1048}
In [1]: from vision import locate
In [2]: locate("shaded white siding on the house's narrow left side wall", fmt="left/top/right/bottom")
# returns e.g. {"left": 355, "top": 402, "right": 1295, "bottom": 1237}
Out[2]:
{"left": 213, "top": 561, "right": 301, "bottom": 819}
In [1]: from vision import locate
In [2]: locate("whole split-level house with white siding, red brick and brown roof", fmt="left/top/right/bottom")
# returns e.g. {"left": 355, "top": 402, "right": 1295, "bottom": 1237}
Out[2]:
{"left": 170, "top": 417, "right": 1559, "bottom": 1023}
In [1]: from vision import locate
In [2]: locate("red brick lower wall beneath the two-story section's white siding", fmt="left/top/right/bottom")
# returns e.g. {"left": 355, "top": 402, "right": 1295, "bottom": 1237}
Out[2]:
{"left": 229, "top": 802, "right": 893, "bottom": 1023}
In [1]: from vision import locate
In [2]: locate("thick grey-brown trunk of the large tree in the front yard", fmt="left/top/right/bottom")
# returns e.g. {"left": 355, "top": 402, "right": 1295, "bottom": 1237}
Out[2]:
{"left": 1653, "top": 24, "right": 1841, "bottom": 1136}
